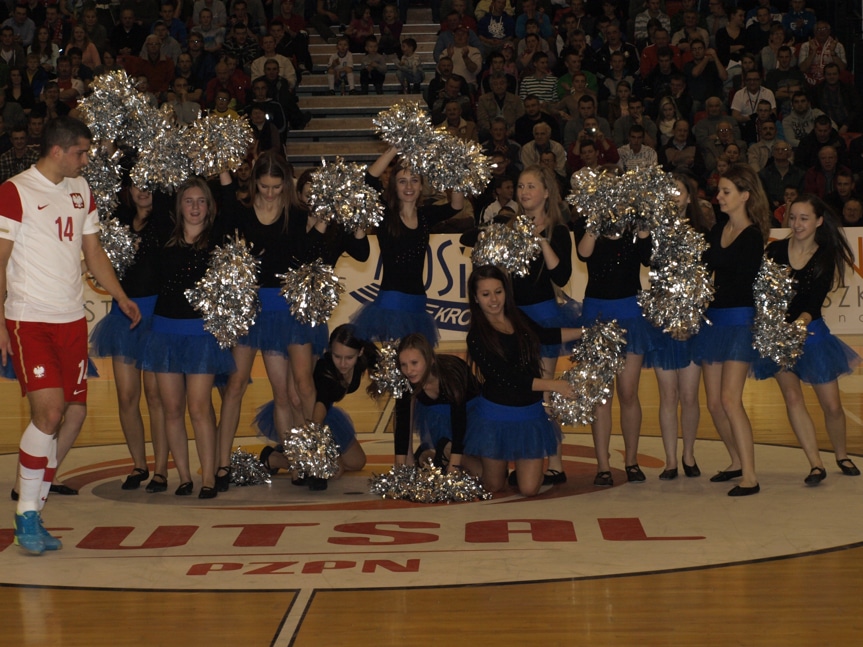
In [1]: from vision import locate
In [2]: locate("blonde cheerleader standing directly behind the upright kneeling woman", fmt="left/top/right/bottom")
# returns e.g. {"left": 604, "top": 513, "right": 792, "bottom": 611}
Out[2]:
{"left": 512, "top": 166, "right": 581, "bottom": 485}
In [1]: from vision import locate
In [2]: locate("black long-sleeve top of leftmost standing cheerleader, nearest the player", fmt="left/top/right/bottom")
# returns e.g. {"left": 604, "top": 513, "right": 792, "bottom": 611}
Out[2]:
{"left": 114, "top": 193, "right": 173, "bottom": 298}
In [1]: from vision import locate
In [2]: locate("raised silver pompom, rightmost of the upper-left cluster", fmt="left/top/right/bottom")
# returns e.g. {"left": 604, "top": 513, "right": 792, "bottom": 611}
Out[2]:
{"left": 181, "top": 115, "right": 255, "bottom": 177}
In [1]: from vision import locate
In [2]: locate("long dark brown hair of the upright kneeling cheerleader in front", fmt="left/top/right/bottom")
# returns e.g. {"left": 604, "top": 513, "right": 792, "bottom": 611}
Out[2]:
{"left": 467, "top": 265, "right": 542, "bottom": 377}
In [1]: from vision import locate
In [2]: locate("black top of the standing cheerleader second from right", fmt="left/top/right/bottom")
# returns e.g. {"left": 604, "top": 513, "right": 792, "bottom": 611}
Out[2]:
{"left": 704, "top": 214, "right": 764, "bottom": 308}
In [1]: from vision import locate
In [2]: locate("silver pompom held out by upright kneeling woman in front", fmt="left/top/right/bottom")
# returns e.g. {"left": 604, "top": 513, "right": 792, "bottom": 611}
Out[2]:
{"left": 548, "top": 321, "right": 626, "bottom": 426}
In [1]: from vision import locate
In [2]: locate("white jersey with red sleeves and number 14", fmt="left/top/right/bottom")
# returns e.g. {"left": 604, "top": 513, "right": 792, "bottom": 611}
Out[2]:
{"left": 0, "top": 165, "right": 99, "bottom": 323}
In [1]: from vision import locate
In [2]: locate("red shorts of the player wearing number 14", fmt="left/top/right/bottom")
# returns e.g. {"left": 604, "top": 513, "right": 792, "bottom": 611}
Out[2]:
{"left": 6, "top": 318, "right": 88, "bottom": 402}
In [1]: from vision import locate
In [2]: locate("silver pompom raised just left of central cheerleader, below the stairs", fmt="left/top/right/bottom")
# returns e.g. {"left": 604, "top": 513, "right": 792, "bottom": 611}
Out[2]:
{"left": 309, "top": 157, "right": 384, "bottom": 232}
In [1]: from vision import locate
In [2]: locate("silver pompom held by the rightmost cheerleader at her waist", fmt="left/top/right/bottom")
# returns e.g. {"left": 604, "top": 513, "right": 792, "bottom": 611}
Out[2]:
{"left": 752, "top": 257, "right": 808, "bottom": 370}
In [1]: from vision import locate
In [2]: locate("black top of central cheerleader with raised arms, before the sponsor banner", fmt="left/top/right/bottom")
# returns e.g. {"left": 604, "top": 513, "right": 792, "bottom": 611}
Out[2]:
{"left": 366, "top": 173, "right": 458, "bottom": 294}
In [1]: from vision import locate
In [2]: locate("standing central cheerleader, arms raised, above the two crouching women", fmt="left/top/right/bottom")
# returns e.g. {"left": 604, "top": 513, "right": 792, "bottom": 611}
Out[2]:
{"left": 351, "top": 148, "right": 464, "bottom": 344}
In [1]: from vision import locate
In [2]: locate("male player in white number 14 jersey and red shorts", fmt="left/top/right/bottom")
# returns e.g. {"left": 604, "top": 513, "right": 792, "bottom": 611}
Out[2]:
{"left": 0, "top": 117, "right": 141, "bottom": 555}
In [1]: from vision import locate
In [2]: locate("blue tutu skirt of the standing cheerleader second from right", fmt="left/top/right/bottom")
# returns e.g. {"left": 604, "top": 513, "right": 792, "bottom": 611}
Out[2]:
{"left": 694, "top": 308, "right": 758, "bottom": 364}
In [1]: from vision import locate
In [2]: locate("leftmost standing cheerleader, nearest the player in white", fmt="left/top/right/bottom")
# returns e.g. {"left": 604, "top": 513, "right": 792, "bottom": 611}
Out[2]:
{"left": 90, "top": 186, "right": 171, "bottom": 493}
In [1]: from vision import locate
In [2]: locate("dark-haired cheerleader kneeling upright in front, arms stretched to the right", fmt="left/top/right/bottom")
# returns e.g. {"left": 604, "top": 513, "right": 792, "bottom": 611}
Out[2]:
{"left": 464, "top": 265, "right": 581, "bottom": 496}
